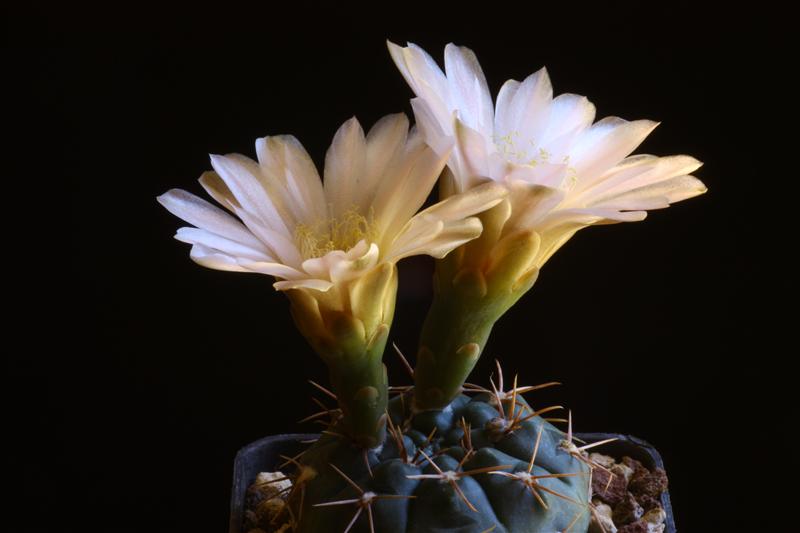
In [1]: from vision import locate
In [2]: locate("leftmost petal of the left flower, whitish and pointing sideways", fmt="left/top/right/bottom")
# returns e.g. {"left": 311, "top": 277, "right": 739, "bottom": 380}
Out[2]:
{"left": 157, "top": 189, "right": 261, "bottom": 249}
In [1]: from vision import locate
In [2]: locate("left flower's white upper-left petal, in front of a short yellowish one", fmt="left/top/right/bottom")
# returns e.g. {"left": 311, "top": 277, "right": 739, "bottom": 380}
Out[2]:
{"left": 211, "top": 155, "right": 292, "bottom": 237}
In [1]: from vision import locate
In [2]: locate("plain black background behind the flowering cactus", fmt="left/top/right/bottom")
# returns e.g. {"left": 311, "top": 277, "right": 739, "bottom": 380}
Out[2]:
{"left": 4, "top": 4, "right": 794, "bottom": 532}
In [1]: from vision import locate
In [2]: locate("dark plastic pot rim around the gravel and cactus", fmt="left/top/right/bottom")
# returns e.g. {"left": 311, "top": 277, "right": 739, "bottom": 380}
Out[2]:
{"left": 228, "top": 433, "right": 677, "bottom": 533}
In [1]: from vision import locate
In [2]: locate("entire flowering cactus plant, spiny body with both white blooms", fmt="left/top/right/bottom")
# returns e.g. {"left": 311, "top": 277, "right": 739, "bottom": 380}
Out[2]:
{"left": 158, "top": 39, "right": 705, "bottom": 533}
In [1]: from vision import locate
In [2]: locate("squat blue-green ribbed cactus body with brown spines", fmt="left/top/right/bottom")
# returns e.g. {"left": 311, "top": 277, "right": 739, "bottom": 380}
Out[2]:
{"left": 291, "top": 393, "right": 590, "bottom": 533}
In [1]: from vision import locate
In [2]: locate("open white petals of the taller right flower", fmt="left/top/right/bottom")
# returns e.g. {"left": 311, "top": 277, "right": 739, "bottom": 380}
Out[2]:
{"left": 389, "top": 43, "right": 706, "bottom": 267}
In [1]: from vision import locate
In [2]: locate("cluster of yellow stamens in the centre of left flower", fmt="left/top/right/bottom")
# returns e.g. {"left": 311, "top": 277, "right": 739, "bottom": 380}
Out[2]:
{"left": 294, "top": 207, "right": 377, "bottom": 259}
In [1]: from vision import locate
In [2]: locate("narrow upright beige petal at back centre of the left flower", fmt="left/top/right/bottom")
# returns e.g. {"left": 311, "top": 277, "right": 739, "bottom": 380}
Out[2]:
{"left": 324, "top": 117, "right": 366, "bottom": 218}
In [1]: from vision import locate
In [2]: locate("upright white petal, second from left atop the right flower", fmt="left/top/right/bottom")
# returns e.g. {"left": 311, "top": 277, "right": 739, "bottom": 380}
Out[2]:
{"left": 444, "top": 43, "right": 494, "bottom": 136}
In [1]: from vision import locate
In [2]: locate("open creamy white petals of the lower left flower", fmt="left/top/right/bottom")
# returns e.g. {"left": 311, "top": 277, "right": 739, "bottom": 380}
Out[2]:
{"left": 158, "top": 114, "right": 503, "bottom": 292}
